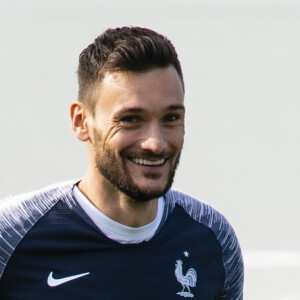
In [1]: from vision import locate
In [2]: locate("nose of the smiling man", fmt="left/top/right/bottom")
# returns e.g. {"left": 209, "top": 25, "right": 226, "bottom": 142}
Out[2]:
{"left": 141, "top": 124, "right": 167, "bottom": 154}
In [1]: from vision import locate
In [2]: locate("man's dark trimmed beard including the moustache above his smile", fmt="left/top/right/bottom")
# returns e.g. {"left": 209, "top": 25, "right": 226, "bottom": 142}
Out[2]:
{"left": 94, "top": 130, "right": 181, "bottom": 202}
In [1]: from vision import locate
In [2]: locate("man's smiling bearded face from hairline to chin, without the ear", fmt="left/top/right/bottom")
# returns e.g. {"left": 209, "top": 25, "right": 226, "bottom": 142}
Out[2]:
{"left": 91, "top": 67, "right": 184, "bottom": 201}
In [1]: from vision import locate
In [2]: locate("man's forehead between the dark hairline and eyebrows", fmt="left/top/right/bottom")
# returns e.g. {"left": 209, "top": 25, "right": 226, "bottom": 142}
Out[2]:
{"left": 95, "top": 66, "right": 184, "bottom": 114}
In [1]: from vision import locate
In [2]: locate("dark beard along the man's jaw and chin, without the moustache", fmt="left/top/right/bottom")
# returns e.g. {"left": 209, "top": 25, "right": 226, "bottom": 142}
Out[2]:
{"left": 94, "top": 132, "right": 181, "bottom": 202}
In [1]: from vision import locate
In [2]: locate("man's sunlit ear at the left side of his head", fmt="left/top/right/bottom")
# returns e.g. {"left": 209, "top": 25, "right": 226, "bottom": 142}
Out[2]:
{"left": 70, "top": 101, "right": 90, "bottom": 142}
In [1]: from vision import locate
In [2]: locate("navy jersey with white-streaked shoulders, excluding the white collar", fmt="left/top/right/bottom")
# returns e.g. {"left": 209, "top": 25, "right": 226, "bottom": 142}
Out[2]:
{"left": 0, "top": 182, "right": 243, "bottom": 300}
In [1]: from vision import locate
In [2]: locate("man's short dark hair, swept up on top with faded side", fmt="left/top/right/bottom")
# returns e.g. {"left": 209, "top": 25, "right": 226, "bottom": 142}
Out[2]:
{"left": 77, "top": 27, "right": 184, "bottom": 113}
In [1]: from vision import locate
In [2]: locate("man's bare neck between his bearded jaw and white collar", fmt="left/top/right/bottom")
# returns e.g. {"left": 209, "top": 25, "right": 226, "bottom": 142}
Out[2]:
{"left": 78, "top": 172, "right": 158, "bottom": 227}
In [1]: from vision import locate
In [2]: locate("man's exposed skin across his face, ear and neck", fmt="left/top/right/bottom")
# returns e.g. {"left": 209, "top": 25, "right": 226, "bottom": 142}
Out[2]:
{"left": 70, "top": 66, "right": 184, "bottom": 227}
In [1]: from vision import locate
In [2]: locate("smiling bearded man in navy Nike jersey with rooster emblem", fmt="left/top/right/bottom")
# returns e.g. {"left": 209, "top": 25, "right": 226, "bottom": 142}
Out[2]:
{"left": 0, "top": 27, "right": 243, "bottom": 300}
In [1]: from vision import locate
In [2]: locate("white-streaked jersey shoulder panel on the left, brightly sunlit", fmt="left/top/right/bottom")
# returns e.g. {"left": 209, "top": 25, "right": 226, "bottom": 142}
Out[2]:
{"left": 0, "top": 181, "right": 75, "bottom": 277}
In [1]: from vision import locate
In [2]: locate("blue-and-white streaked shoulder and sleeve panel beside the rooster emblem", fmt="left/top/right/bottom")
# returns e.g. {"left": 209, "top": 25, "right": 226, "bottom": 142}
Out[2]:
{"left": 166, "top": 190, "right": 244, "bottom": 300}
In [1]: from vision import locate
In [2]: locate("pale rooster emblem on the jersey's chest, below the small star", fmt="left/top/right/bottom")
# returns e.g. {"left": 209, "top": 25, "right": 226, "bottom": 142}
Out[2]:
{"left": 175, "top": 260, "right": 197, "bottom": 298}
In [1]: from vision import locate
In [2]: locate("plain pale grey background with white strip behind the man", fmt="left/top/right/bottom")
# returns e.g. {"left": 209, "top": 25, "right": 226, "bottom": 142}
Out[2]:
{"left": 0, "top": 0, "right": 300, "bottom": 300}
